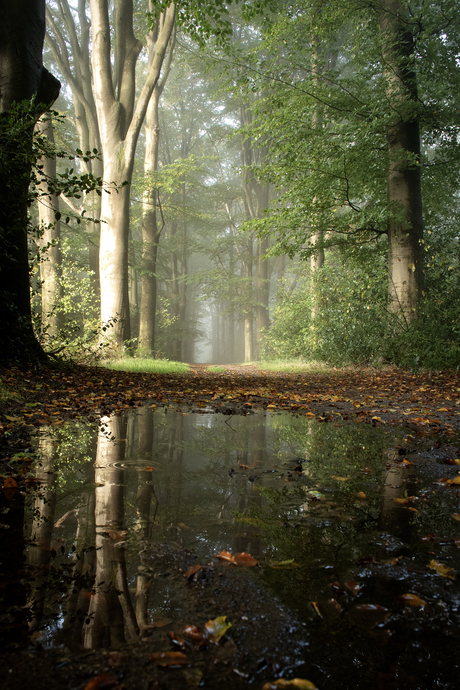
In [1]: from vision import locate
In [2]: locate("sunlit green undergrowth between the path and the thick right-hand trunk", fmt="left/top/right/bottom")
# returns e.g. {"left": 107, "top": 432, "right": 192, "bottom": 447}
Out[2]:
{"left": 264, "top": 251, "right": 392, "bottom": 365}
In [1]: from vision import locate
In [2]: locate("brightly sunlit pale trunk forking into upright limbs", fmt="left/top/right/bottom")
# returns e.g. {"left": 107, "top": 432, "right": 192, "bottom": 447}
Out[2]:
{"left": 90, "top": 0, "right": 175, "bottom": 349}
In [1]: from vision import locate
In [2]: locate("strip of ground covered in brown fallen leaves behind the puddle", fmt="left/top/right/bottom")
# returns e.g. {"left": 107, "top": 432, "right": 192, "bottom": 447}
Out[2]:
{"left": 0, "top": 364, "right": 460, "bottom": 436}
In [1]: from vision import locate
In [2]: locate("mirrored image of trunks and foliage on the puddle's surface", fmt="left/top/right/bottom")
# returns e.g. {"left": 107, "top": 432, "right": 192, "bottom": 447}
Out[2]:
{"left": 2, "top": 407, "right": 458, "bottom": 680}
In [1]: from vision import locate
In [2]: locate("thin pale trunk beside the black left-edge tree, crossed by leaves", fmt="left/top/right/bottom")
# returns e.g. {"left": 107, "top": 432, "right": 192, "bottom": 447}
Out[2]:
{"left": 36, "top": 115, "right": 63, "bottom": 339}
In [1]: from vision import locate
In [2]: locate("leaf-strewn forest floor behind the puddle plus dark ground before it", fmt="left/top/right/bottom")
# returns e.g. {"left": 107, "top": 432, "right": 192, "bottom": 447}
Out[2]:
{"left": 0, "top": 365, "right": 460, "bottom": 690}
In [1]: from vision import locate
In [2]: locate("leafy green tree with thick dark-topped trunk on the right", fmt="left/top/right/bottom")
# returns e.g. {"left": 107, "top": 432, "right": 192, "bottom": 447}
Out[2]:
{"left": 237, "top": 0, "right": 460, "bottom": 328}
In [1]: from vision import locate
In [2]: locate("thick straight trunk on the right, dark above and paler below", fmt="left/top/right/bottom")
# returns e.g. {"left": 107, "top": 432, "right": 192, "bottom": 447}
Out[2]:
{"left": 381, "top": 0, "right": 423, "bottom": 324}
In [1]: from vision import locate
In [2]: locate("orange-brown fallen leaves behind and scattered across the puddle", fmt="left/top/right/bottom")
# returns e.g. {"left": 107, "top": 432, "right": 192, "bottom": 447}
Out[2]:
{"left": 0, "top": 368, "right": 460, "bottom": 690}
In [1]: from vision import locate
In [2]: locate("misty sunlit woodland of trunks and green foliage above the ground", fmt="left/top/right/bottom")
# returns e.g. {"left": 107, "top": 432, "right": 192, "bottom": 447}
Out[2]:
{"left": 1, "top": 0, "right": 460, "bottom": 369}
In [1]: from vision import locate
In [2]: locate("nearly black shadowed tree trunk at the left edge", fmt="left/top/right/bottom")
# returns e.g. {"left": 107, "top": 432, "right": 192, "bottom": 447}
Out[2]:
{"left": 0, "top": 0, "right": 60, "bottom": 360}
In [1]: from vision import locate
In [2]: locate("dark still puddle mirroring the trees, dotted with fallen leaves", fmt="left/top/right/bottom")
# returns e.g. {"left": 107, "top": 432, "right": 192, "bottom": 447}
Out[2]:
{"left": 0, "top": 408, "right": 460, "bottom": 690}
